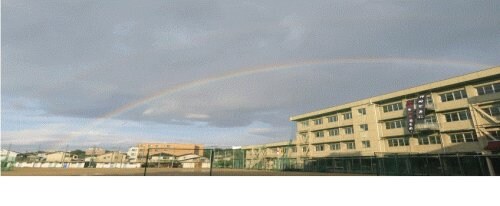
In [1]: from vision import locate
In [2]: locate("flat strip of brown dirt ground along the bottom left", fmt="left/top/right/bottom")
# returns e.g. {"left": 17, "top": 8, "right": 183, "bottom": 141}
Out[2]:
{"left": 1, "top": 168, "right": 368, "bottom": 176}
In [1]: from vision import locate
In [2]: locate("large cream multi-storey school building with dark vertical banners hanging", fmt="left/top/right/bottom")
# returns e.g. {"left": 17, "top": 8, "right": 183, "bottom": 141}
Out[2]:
{"left": 245, "top": 67, "right": 500, "bottom": 167}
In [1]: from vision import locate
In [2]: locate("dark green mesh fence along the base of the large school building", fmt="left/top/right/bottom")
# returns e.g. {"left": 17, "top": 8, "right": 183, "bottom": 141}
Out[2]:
{"left": 304, "top": 154, "right": 500, "bottom": 176}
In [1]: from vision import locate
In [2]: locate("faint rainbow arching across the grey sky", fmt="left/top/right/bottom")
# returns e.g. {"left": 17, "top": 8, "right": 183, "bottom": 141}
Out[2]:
{"left": 52, "top": 57, "right": 491, "bottom": 148}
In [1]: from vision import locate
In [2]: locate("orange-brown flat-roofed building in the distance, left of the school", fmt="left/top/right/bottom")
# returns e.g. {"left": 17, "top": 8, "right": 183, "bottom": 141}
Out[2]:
{"left": 137, "top": 143, "right": 203, "bottom": 162}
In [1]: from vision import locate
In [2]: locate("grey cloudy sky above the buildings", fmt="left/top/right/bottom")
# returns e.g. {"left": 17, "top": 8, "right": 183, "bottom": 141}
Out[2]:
{"left": 1, "top": 0, "right": 500, "bottom": 150}
